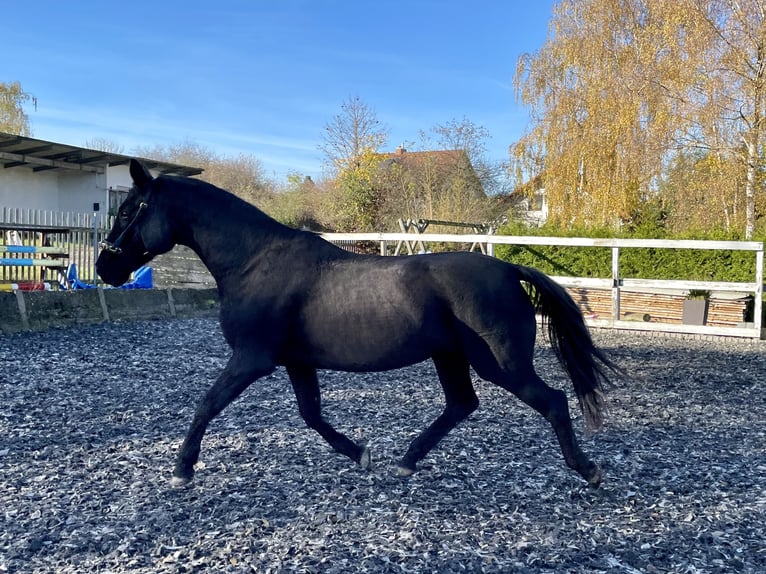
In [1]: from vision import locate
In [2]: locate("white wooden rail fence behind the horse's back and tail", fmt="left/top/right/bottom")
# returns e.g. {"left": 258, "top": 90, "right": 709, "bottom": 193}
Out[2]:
{"left": 322, "top": 233, "right": 766, "bottom": 338}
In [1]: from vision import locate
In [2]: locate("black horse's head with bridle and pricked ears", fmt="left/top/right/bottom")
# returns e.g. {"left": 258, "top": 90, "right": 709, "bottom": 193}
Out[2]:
{"left": 96, "top": 159, "right": 175, "bottom": 286}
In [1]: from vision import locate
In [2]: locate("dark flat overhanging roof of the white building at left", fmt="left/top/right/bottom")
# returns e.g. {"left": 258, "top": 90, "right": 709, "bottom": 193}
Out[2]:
{"left": 0, "top": 132, "right": 203, "bottom": 177}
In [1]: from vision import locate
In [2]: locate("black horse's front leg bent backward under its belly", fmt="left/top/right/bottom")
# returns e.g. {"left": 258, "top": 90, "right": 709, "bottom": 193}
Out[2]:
{"left": 287, "top": 366, "right": 370, "bottom": 468}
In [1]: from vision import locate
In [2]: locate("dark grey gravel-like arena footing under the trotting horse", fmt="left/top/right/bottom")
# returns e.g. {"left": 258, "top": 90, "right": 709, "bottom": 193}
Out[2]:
{"left": 0, "top": 319, "right": 766, "bottom": 573}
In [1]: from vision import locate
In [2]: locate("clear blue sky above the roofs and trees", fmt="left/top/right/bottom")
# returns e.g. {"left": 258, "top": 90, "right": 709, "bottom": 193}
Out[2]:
{"left": 0, "top": 0, "right": 555, "bottom": 180}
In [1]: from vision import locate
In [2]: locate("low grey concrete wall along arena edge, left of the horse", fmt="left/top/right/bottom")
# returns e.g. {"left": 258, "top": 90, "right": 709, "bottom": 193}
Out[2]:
{"left": 0, "top": 288, "right": 218, "bottom": 334}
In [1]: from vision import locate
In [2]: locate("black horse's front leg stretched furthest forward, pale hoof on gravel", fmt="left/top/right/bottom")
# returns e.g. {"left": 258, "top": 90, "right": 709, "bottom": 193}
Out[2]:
{"left": 171, "top": 350, "right": 275, "bottom": 486}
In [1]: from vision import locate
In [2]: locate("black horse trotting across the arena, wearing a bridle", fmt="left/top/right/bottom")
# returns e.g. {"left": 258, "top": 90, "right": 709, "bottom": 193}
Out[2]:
{"left": 96, "top": 160, "right": 620, "bottom": 486}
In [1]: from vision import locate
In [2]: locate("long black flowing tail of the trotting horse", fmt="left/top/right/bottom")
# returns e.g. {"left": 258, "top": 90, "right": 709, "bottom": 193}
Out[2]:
{"left": 515, "top": 265, "right": 623, "bottom": 429}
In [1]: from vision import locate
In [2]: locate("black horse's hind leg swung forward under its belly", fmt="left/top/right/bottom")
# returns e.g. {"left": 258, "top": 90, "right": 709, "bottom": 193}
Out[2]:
{"left": 399, "top": 354, "right": 479, "bottom": 476}
